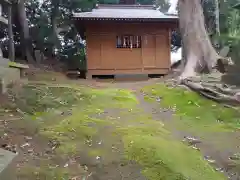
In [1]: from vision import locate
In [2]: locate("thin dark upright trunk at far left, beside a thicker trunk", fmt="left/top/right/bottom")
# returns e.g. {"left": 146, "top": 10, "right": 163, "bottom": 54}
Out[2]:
{"left": 8, "top": 5, "right": 15, "bottom": 61}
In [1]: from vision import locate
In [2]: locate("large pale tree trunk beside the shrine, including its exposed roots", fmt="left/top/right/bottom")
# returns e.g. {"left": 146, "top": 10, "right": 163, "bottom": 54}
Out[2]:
{"left": 176, "top": 0, "right": 240, "bottom": 107}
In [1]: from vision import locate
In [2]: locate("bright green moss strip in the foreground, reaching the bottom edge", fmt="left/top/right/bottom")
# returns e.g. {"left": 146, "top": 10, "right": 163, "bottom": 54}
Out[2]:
{"left": 115, "top": 111, "right": 225, "bottom": 180}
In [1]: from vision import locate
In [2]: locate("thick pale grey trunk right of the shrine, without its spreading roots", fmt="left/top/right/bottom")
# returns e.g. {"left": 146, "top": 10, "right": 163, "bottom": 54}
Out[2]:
{"left": 179, "top": 0, "right": 219, "bottom": 79}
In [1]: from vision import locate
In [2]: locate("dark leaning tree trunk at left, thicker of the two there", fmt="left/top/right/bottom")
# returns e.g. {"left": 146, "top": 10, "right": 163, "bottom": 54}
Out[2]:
{"left": 18, "top": 0, "right": 34, "bottom": 63}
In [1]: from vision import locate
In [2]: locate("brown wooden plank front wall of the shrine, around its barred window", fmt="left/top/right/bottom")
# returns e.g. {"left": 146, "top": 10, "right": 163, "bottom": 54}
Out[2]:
{"left": 86, "top": 22, "right": 170, "bottom": 74}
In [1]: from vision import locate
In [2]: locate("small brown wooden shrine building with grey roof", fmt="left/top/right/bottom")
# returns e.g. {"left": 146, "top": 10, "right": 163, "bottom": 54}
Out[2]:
{"left": 74, "top": 0, "right": 178, "bottom": 77}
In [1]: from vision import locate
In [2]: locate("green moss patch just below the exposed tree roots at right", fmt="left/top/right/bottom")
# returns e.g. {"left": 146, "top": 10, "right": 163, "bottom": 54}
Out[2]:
{"left": 143, "top": 84, "right": 240, "bottom": 131}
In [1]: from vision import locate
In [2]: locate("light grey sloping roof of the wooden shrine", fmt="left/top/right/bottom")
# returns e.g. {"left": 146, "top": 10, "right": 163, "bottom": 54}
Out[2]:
{"left": 73, "top": 5, "right": 178, "bottom": 20}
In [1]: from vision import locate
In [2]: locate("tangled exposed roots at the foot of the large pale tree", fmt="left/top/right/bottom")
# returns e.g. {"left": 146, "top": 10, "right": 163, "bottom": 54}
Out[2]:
{"left": 178, "top": 52, "right": 240, "bottom": 107}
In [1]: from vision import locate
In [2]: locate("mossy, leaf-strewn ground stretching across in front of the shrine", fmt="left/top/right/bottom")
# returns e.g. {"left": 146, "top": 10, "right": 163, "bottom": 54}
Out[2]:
{"left": 0, "top": 72, "right": 240, "bottom": 180}
